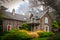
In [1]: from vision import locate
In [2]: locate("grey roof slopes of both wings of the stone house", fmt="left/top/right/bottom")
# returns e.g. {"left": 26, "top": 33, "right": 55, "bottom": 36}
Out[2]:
{"left": 4, "top": 11, "right": 50, "bottom": 21}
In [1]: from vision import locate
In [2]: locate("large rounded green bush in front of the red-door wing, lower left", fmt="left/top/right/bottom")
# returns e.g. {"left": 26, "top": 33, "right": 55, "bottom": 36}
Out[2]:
{"left": 2, "top": 30, "right": 30, "bottom": 40}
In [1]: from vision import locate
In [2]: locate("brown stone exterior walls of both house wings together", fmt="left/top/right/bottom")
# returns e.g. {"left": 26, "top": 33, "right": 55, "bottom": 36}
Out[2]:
{"left": 3, "top": 13, "right": 52, "bottom": 31}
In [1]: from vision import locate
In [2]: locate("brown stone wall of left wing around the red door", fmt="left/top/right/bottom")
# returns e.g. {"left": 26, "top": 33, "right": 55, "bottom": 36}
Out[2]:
{"left": 3, "top": 20, "right": 23, "bottom": 31}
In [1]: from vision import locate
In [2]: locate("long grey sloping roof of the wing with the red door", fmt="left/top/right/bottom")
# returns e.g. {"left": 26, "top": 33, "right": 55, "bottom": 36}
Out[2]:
{"left": 3, "top": 12, "right": 27, "bottom": 21}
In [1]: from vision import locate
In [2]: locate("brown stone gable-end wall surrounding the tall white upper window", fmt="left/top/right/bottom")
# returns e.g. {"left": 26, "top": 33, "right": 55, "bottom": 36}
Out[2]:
{"left": 41, "top": 13, "right": 52, "bottom": 31}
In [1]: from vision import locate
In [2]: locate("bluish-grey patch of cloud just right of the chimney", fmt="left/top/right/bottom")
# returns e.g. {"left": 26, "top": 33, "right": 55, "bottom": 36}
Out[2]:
{"left": 16, "top": 1, "right": 29, "bottom": 13}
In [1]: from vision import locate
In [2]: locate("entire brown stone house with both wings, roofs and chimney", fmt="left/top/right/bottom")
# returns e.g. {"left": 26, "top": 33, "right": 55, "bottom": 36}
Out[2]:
{"left": 0, "top": 6, "right": 52, "bottom": 32}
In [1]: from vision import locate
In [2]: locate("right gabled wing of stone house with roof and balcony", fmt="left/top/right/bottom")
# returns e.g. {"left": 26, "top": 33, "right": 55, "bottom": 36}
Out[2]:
{"left": 28, "top": 11, "right": 52, "bottom": 32}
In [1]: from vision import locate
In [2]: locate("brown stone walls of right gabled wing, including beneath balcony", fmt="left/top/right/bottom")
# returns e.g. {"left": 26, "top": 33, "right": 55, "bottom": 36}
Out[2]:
{"left": 31, "top": 13, "right": 52, "bottom": 32}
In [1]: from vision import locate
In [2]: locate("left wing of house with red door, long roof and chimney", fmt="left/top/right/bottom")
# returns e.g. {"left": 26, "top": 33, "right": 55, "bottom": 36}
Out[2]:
{"left": 0, "top": 9, "right": 26, "bottom": 31}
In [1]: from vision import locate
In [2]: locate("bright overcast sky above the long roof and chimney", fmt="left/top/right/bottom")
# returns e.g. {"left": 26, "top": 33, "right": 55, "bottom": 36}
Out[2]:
{"left": 0, "top": 0, "right": 42, "bottom": 15}
